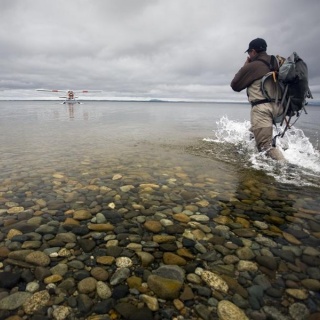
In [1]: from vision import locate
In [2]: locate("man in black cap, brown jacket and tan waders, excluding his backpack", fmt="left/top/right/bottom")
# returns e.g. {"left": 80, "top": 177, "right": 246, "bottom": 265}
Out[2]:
{"left": 231, "top": 38, "right": 285, "bottom": 160}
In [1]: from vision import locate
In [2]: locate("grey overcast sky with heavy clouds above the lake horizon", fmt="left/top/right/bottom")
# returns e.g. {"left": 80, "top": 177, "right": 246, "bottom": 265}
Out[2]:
{"left": 0, "top": 0, "right": 320, "bottom": 100}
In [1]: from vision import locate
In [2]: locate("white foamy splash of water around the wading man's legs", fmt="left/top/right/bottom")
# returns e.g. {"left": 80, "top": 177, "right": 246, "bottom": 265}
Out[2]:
{"left": 204, "top": 116, "right": 320, "bottom": 187}
